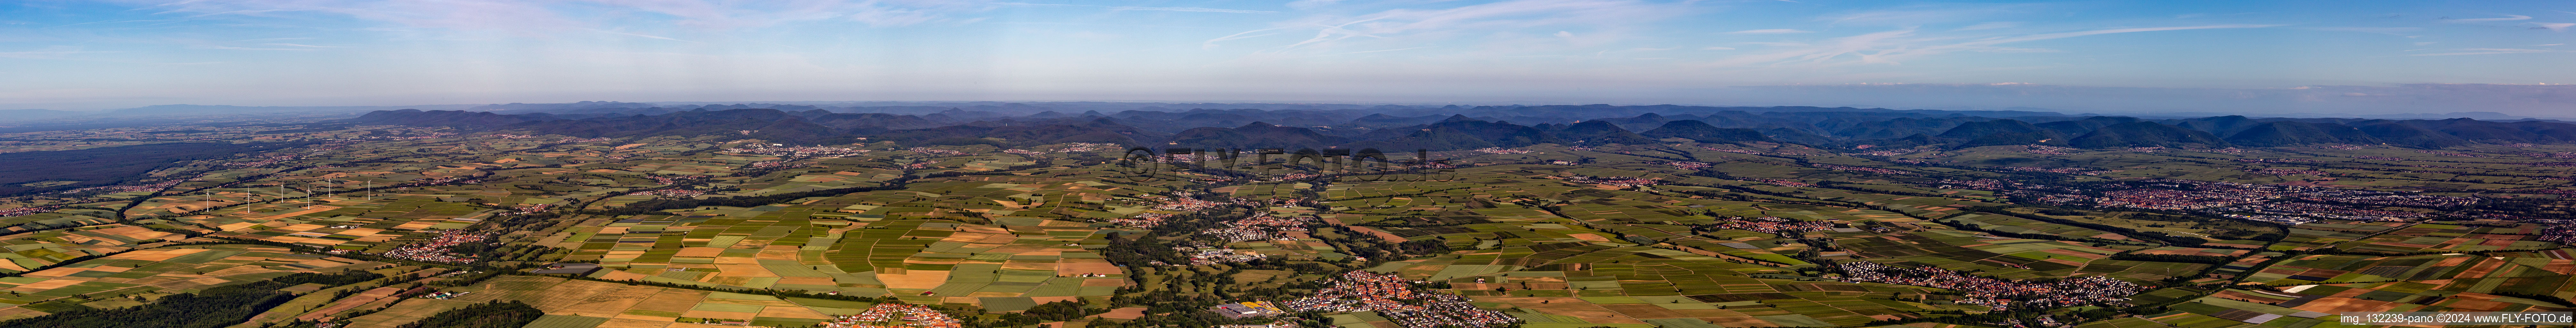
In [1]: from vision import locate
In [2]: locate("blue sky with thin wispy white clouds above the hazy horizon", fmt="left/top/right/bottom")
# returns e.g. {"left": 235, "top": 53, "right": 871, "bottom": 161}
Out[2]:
{"left": 0, "top": 0, "right": 2576, "bottom": 116}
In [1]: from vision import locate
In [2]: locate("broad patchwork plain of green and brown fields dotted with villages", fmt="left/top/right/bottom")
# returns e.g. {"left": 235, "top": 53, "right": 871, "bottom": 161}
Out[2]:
{"left": 0, "top": 113, "right": 2576, "bottom": 328}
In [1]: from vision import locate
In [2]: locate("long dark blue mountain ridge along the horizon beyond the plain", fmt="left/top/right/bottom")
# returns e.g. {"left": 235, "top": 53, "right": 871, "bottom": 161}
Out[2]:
{"left": 350, "top": 101, "right": 2576, "bottom": 150}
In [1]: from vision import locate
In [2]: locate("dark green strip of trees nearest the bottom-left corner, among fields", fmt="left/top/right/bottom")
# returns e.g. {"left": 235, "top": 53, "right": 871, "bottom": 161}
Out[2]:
{"left": 0, "top": 271, "right": 384, "bottom": 328}
